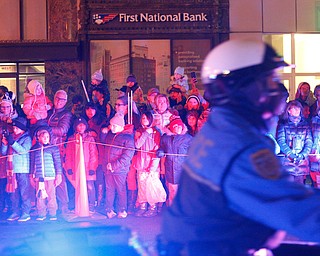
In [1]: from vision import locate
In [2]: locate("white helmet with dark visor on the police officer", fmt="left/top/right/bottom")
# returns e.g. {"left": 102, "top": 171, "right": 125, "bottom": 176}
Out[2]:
{"left": 201, "top": 40, "right": 288, "bottom": 84}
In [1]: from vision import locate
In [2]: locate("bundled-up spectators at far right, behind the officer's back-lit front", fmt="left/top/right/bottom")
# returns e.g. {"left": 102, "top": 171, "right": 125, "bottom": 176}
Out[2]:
{"left": 276, "top": 82, "right": 320, "bottom": 188}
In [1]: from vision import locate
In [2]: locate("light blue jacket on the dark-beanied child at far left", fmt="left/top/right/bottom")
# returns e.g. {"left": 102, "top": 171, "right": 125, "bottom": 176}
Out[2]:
{"left": 1, "top": 132, "right": 32, "bottom": 173}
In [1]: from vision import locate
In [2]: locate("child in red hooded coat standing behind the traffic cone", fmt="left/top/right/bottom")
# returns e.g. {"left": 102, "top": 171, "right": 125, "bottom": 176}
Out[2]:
{"left": 65, "top": 117, "right": 98, "bottom": 213}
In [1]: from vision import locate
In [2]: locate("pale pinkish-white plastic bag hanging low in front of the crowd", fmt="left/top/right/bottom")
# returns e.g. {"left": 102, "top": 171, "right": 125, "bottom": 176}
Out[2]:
{"left": 146, "top": 172, "right": 167, "bottom": 204}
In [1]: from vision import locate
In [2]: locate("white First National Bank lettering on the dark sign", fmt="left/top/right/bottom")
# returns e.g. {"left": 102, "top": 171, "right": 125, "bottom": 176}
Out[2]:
{"left": 119, "top": 12, "right": 208, "bottom": 22}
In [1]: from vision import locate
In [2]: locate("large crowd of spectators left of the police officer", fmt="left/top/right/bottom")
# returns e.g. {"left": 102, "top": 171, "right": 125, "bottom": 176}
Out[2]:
{"left": 0, "top": 67, "right": 210, "bottom": 222}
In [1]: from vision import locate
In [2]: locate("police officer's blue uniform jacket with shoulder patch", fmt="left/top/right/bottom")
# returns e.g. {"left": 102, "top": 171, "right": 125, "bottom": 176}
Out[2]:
{"left": 162, "top": 107, "right": 320, "bottom": 256}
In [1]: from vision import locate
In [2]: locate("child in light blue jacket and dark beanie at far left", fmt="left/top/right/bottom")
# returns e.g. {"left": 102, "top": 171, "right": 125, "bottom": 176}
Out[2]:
{"left": 1, "top": 117, "right": 32, "bottom": 222}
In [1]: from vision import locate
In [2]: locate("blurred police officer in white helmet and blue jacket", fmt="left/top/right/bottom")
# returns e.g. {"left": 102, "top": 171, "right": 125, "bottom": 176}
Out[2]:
{"left": 162, "top": 40, "right": 320, "bottom": 256}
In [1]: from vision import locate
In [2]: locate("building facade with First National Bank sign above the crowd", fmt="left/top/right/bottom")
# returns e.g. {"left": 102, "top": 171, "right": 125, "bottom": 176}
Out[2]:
{"left": 0, "top": 0, "right": 320, "bottom": 102}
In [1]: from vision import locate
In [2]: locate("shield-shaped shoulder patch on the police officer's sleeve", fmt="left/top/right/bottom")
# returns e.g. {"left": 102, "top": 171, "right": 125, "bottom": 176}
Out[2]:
{"left": 250, "top": 149, "right": 281, "bottom": 179}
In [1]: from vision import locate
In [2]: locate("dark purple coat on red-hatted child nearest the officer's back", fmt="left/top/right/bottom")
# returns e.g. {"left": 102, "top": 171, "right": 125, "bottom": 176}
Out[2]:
{"left": 160, "top": 134, "right": 193, "bottom": 184}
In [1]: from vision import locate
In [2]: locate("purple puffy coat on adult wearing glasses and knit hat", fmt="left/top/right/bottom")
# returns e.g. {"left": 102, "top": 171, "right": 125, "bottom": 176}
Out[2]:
{"left": 48, "top": 107, "right": 72, "bottom": 146}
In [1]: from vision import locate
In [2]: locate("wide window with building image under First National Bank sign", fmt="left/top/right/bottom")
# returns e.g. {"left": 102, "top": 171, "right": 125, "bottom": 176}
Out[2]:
{"left": 90, "top": 39, "right": 211, "bottom": 102}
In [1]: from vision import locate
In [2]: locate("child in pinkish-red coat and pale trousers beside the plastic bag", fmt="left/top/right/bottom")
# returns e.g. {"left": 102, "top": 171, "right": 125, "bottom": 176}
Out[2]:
{"left": 134, "top": 111, "right": 161, "bottom": 217}
